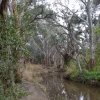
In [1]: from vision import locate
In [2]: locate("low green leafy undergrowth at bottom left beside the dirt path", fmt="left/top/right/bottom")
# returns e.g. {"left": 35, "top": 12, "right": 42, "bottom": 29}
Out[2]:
{"left": 0, "top": 84, "right": 29, "bottom": 100}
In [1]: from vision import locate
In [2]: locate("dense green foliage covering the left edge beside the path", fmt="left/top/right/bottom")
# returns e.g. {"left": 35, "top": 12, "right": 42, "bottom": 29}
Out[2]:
{"left": 0, "top": 16, "right": 28, "bottom": 100}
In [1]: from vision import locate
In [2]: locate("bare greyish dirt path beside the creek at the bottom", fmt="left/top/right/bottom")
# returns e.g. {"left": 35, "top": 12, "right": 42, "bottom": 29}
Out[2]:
{"left": 20, "top": 82, "right": 48, "bottom": 100}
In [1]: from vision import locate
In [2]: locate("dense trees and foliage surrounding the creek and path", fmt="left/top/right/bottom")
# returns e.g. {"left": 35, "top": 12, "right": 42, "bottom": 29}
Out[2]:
{"left": 0, "top": 0, "right": 100, "bottom": 100}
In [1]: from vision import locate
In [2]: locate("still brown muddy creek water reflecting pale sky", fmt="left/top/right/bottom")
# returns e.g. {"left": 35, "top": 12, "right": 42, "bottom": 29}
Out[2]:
{"left": 44, "top": 74, "right": 100, "bottom": 100}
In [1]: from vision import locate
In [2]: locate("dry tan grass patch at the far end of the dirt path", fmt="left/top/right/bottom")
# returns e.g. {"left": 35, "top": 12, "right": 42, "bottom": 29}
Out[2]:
{"left": 23, "top": 63, "right": 45, "bottom": 83}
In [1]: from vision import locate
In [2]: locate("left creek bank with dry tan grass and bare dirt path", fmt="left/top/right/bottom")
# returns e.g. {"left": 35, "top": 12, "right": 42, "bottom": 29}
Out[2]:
{"left": 20, "top": 63, "right": 58, "bottom": 100}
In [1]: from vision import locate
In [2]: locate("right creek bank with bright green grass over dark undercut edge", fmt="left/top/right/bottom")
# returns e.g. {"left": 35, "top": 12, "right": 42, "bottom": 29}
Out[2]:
{"left": 64, "top": 69, "right": 100, "bottom": 86}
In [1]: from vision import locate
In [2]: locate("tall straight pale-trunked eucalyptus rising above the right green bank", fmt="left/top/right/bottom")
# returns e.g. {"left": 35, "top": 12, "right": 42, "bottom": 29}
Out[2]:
{"left": 78, "top": 0, "right": 94, "bottom": 69}
